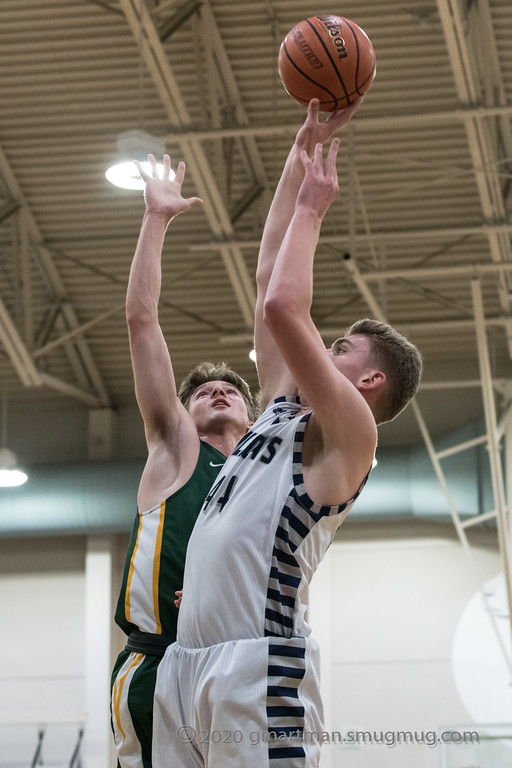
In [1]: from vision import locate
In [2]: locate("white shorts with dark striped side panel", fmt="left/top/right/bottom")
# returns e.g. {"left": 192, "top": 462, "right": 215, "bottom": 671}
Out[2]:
{"left": 153, "top": 637, "right": 323, "bottom": 768}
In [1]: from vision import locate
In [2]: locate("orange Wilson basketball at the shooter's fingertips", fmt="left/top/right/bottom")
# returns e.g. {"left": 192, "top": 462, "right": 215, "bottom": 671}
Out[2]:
{"left": 277, "top": 14, "right": 375, "bottom": 112}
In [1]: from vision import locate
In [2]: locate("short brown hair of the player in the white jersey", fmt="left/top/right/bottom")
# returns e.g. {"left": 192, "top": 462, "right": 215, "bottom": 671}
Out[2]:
{"left": 346, "top": 318, "right": 423, "bottom": 424}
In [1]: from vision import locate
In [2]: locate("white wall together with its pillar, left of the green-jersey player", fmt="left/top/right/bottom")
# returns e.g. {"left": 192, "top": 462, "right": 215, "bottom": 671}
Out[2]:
{"left": 0, "top": 536, "right": 126, "bottom": 768}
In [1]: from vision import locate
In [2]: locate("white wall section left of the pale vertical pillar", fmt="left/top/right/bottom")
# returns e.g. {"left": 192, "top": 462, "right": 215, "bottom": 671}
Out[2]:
{"left": 0, "top": 537, "right": 85, "bottom": 766}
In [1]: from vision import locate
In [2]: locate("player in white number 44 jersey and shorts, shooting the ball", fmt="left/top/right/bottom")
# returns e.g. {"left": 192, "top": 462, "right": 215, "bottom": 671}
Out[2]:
{"left": 153, "top": 101, "right": 422, "bottom": 768}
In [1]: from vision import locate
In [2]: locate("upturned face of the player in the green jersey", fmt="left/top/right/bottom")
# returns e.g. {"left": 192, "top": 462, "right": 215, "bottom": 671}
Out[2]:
{"left": 188, "top": 381, "right": 249, "bottom": 433}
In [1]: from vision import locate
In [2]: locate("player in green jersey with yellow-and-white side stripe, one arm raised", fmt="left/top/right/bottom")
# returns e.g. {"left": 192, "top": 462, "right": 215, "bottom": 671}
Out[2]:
{"left": 111, "top": 155, "right": 254, "bottom": 768}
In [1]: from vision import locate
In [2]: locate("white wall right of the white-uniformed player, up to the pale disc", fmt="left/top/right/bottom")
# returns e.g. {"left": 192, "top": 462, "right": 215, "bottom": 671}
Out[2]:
{"left": 310, "top": 523, "right": 504, "bottom": 768}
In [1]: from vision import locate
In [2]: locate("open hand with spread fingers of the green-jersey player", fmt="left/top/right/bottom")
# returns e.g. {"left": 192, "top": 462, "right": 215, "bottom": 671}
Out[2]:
{"left": 134, "top": 155, "right": 203, "bottom": 221}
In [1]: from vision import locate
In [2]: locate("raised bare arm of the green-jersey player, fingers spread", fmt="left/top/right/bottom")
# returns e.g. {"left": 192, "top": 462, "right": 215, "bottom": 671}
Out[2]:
{"left": 126, "top": 155, "right": 202, "bottom": 504}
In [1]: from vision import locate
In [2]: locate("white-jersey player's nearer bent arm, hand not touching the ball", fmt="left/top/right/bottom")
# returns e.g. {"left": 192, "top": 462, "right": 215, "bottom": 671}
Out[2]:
{"left": 264, "top": 139, "right": 377, "bottom": 503}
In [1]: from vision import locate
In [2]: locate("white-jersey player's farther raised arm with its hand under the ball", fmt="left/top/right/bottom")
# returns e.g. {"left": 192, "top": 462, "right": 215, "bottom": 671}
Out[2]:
{"left": 254, "top": 99, "right": 360, "bottom": 406}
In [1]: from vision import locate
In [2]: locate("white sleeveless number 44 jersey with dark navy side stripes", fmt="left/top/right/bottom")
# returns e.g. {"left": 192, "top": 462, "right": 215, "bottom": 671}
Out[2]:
{"left": 177, "top": 397, "right": 370, "bottom": 648}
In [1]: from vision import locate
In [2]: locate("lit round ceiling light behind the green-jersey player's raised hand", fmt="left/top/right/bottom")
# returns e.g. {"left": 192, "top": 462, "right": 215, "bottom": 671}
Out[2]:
{"left": 105, "top": 130, "right": 176, "bottom": 189}
